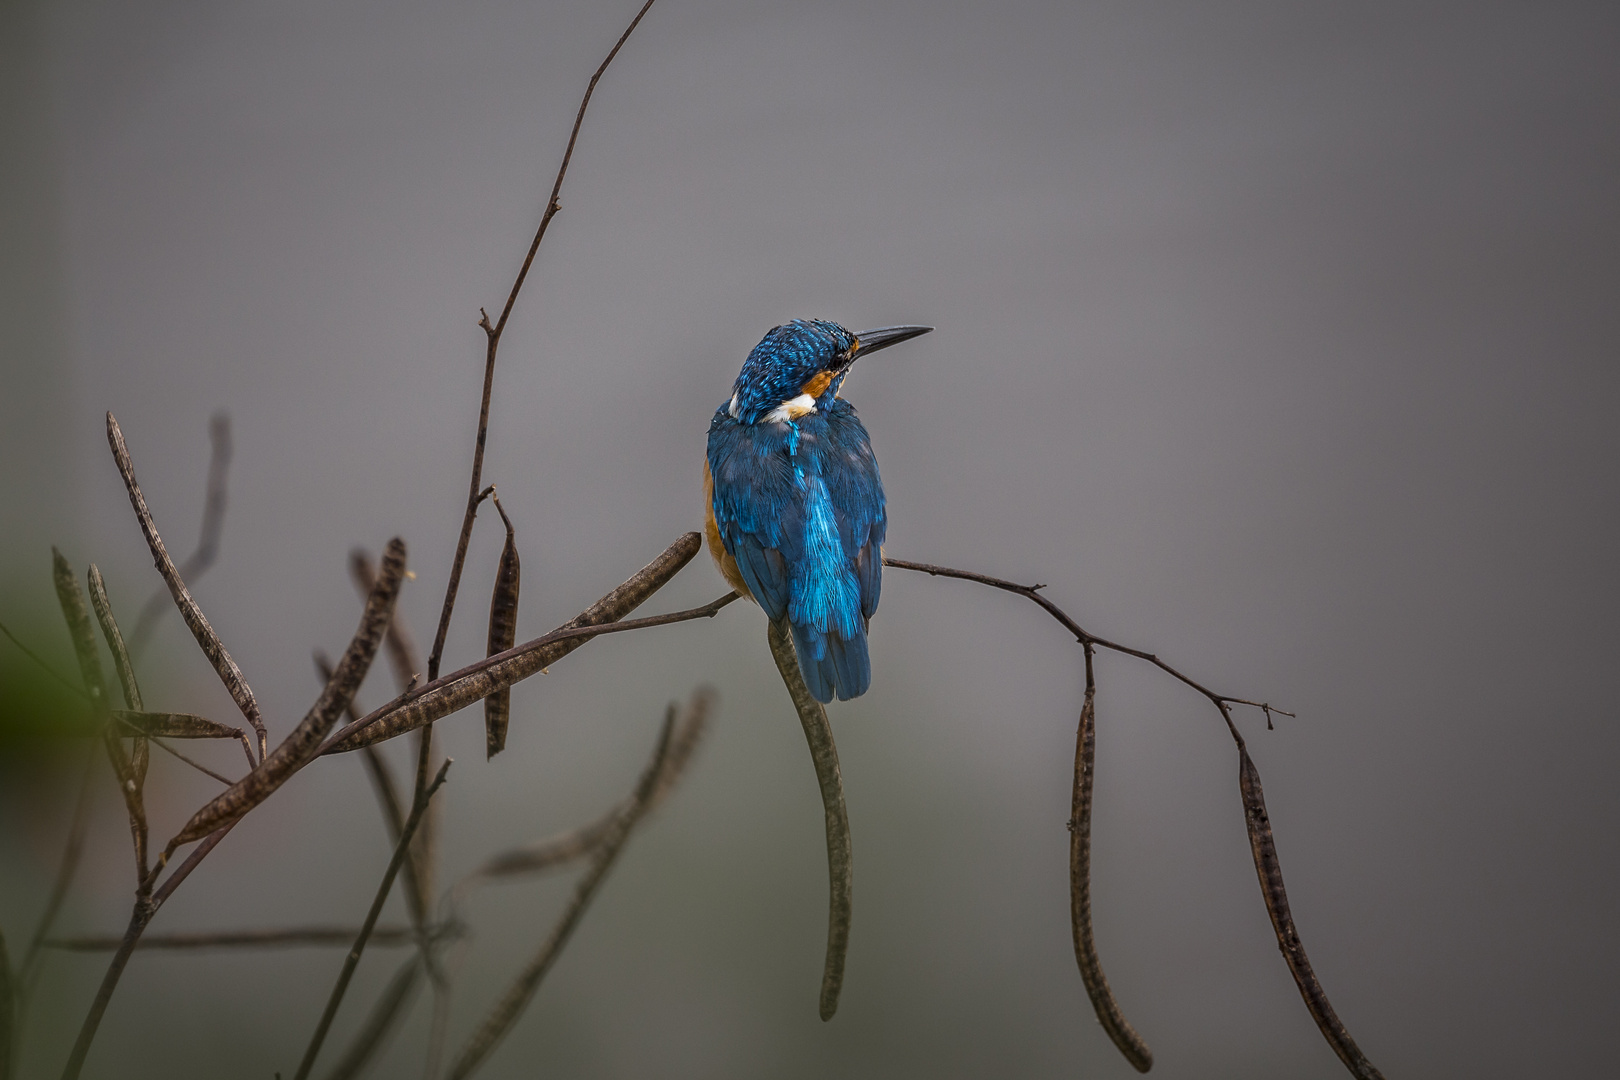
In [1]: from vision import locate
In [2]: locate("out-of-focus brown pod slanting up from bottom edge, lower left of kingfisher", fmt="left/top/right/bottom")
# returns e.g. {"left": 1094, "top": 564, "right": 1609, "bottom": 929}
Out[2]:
{"left": 450, "top": 688, "right": 714, "bottom": 1080}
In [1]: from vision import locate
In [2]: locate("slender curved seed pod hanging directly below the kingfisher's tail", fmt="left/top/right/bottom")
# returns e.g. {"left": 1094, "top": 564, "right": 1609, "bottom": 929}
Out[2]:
{"left": 770, "top": 622, "right": 855, "bottom": 1020}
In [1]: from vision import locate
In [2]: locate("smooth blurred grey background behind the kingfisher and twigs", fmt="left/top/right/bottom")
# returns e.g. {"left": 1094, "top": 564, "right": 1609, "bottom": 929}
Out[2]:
{"left": 0, "top": 0, "right": 1620, "bottom": 1078}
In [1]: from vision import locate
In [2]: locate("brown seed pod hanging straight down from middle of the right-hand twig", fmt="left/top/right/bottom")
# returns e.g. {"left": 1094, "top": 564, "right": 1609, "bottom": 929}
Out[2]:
{"left": 1069, "top": 644, "right": 1153, "bottom": 1072}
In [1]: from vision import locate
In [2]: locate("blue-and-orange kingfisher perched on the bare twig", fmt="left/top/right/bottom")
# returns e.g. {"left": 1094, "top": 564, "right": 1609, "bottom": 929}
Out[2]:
{"left": 703, "top": 319, "right": 933, "bottom": 704}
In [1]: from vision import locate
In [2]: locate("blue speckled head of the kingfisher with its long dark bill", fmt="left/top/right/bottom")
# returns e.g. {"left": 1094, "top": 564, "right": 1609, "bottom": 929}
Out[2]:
{"left": 727, "top": 319, "right": 933, "bottom": 424}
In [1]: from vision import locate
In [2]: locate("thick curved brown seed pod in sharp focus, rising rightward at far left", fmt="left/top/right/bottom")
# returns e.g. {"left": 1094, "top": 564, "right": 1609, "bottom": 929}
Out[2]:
{"left": 165, "top": 536, "right": 405, "bottom": 855}
